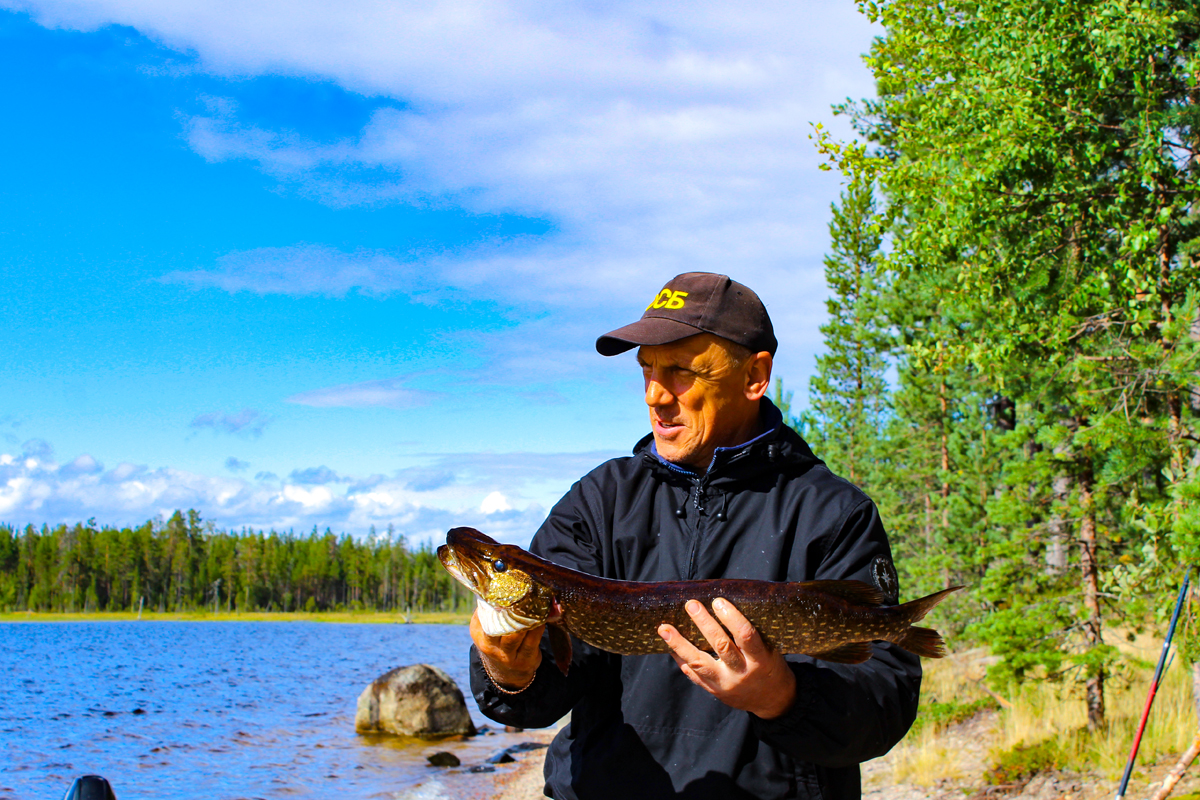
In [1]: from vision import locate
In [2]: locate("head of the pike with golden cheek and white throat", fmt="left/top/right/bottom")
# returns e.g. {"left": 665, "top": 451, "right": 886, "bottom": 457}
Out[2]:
{"left": 438, "top": 528, "right": 556, "bottom": 636}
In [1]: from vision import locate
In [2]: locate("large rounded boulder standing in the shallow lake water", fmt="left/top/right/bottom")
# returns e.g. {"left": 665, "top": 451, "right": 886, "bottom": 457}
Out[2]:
{"left": 354, "top": 664, "right": 475, "bottom": 736}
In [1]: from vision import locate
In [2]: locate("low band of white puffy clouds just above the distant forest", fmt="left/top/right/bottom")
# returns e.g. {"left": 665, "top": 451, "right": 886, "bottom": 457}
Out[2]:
{"left": 0, "top": 441, "right": 608, "bottom": 543}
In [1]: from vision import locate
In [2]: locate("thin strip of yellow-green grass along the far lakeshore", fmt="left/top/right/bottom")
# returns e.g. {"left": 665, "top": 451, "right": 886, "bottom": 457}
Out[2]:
{"left": 0, "top": 610, "right": 470, "bottom": 625}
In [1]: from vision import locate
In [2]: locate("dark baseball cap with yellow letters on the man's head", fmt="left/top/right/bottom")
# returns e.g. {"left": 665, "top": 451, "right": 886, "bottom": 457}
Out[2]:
{"left": 596, "top": 272, "right": 779, "bottom": 355}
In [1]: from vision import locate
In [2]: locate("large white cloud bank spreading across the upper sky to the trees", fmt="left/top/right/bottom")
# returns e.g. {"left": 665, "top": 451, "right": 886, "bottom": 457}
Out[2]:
{"left": 0, "top": 0, "right": 874, "bottom": 383}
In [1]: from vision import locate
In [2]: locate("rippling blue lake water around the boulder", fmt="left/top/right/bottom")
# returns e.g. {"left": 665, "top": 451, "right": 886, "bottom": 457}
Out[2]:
{"left": 0, "top": 621, "right": 540, "bottom": 800}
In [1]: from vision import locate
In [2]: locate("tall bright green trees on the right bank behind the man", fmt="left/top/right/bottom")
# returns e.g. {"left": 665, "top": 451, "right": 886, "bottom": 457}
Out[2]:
{"left": 796, "top": 0, "right": 1200, "bottom": 728}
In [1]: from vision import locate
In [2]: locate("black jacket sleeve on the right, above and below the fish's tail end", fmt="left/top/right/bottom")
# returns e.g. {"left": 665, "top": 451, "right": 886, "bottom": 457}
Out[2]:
{"left": 751, "top": 499, "right": 922, "bottom": 768}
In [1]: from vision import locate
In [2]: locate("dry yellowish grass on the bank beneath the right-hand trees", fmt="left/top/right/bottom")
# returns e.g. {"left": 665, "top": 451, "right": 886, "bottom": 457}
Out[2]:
{"left": 888, "top": 636, "right": 1200, "bottom": 800}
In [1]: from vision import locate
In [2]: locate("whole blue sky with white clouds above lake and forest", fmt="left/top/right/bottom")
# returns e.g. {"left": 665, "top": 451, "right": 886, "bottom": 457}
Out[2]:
{"left": 0, "top": 0, "right": 877, "bottom": 543}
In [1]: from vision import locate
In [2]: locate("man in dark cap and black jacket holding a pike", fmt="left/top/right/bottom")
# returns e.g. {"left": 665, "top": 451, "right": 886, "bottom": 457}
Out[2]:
{"left": 470, "top": 272, "right": 920, "bottom": 800}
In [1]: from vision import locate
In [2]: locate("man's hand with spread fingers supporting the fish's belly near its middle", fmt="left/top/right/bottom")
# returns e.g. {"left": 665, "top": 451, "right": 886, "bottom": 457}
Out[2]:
{"left": 659, "top": 597, "right": 796, "bottom": 720}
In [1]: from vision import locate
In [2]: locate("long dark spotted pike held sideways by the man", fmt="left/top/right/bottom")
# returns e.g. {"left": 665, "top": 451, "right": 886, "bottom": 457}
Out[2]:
{"left": 438, "top": 528, "right": 962, "bottom": 675}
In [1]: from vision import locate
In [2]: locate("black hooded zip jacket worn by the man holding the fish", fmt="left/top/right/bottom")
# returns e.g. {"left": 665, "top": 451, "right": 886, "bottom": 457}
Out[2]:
{"left": 470, "top": 401, "right": 920, "bottom": 800}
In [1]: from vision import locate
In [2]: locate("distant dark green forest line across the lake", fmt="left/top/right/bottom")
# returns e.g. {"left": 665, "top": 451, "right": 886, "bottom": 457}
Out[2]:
{"left": 0, "top": 511, "right": 472, "bottom": 613}
